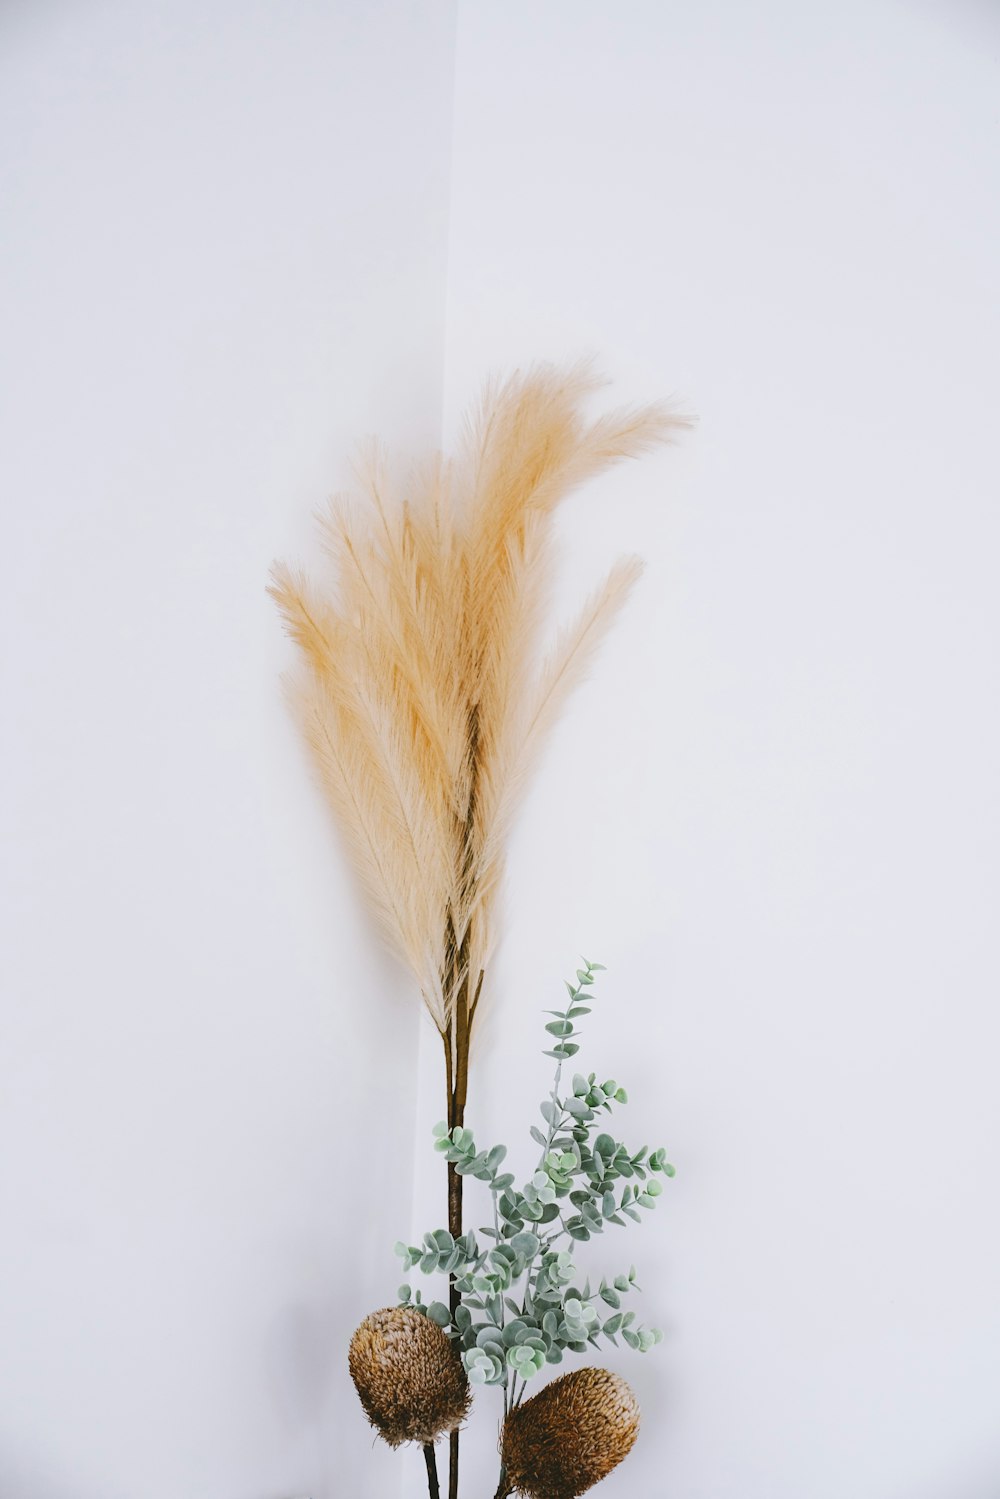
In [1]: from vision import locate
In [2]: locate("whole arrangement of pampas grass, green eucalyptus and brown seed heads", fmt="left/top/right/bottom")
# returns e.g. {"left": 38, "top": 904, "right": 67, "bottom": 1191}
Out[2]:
{"left": 270, "top": 366, "right": 687, "bottom": 1499}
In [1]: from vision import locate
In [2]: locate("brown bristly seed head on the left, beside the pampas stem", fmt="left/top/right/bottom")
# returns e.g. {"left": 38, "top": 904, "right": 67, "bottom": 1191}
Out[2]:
{"left": 348, "top": 1307, "right": 469, "bottom": 1447}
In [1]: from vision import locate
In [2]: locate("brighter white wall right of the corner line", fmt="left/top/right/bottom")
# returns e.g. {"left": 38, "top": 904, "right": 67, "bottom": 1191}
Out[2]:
{"left": 437, "top": 0, "right": 1000, "bottom": 1499}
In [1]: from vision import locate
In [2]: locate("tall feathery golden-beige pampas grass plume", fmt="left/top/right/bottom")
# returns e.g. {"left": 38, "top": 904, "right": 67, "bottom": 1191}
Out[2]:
{"left": 270, "top": 364, "right": 687, "bottom": 1043}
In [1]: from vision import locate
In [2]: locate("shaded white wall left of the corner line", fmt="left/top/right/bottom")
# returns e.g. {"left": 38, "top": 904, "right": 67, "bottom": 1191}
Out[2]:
{"left": 0, "top": 0, "right": 454, "bottom": 1499}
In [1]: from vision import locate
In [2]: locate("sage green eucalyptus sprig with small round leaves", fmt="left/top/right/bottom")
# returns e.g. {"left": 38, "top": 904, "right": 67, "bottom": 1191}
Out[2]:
{"left": 396, "top": 959, "right": 673, "bottom": 1406}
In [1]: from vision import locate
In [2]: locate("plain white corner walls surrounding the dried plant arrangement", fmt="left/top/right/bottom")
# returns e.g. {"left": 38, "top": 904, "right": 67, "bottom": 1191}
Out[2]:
{"left": 0, "top": 0, "right": 1000, "bottom": 1499}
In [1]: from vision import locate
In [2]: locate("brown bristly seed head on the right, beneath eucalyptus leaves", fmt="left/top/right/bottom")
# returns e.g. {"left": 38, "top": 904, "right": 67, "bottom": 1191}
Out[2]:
{"left": 501, "top": 1369, "right": 639, "bottom": 1499}
